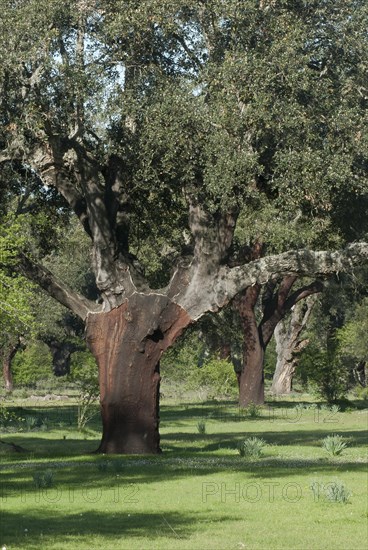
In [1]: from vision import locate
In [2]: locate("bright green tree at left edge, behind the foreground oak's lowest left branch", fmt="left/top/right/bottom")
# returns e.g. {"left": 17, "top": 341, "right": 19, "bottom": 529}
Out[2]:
{"left": 0, "top": 172, "right": 87, "bottom": 389}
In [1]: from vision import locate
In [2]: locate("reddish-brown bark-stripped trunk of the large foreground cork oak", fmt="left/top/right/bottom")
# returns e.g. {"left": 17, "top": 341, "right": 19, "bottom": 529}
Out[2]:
{"left": 87, "top": 294, "right": 191, "bottom": 454}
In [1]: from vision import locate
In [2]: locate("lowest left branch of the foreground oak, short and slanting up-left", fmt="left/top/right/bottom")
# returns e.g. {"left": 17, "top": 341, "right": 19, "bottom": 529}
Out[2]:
{"left": 18, "top": 254, "right": 101, "bottom": 320}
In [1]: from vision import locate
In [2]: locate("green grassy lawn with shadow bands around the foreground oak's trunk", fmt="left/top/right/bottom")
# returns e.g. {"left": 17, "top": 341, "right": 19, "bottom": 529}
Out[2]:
{"left": 0, "top": 401, "right": 368, "bottom": 550}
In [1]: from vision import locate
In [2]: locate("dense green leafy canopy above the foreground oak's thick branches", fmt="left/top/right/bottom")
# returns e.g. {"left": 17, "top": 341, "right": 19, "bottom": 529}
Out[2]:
{"left": 0, "top": 0, "right": 367, "bottom": 278}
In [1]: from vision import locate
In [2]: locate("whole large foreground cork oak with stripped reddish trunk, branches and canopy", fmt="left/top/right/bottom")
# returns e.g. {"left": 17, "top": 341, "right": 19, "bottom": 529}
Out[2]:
{"left": 0, "top": 0, "right": 368, "bottom": 453}
